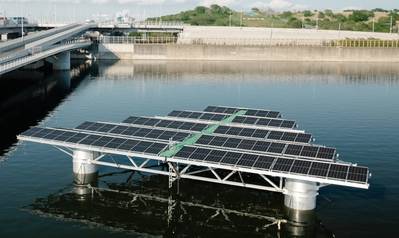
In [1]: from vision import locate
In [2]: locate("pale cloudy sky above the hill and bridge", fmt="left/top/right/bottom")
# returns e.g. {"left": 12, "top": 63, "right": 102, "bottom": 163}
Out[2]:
{"left": 0, "top": 0, "right": 399, "bottom": 21}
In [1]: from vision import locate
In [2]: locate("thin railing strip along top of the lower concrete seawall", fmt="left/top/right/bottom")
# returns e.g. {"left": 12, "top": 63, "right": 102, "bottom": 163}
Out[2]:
{"left": 100, "top": 36, "right": 399, "bottom": 48}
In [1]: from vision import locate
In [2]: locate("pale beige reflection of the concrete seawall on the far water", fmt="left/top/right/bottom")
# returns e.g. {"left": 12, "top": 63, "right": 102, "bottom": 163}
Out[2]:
{"left": 97, "top": 60, "right": 399, "bottom": 85}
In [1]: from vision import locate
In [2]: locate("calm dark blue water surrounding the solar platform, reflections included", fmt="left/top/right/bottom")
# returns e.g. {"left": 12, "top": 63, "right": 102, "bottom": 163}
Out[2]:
{"left": 0, "top": 61, "right": 399, "bottom": 237}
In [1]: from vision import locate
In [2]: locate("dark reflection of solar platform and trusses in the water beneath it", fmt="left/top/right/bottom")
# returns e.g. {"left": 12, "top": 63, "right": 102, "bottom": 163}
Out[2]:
{"left": 29, "top": 171, "right": 333, "bottom": 237}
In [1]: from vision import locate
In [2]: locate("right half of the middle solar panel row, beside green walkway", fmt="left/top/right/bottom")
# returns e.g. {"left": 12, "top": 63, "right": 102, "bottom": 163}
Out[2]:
{"left": 215, "top": 126, "right": 312, "bottom": 143}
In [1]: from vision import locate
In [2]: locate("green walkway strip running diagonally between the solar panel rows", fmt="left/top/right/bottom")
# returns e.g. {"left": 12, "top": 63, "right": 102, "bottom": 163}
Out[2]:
{"left": 159, "top": 110, "right": 247, "bottom": 158}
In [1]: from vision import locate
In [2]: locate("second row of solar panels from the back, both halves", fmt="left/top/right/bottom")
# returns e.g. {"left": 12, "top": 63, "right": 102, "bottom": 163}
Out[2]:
{"left": 168, "top": 111, "right": 296, "bottom": 129}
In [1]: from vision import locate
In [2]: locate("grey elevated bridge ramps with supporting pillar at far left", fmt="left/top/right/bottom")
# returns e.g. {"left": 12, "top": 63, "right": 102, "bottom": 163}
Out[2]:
{"left": 0, "top": 24, "right": 96, "bottom": 75}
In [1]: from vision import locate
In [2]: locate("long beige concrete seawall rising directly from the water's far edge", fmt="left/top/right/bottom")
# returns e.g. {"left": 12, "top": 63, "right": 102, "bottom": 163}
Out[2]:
{"left": 97, "top": 44, "right": 399, "bottom": 62}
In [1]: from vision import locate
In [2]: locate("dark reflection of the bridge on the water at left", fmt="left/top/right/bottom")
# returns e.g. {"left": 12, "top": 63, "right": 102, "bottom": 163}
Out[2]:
{"left": 0, "top": 62, "right": 91, "bottom": 155}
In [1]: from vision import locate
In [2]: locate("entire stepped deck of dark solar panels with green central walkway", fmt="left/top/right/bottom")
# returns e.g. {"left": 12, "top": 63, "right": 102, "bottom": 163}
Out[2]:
{"left": 19, "top": 107, "right": 369, "bottom": 192}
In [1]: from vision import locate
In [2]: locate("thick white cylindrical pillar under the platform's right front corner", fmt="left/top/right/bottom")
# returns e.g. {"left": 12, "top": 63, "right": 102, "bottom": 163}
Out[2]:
{"left": 284, "top": 179, "right": 319, "bottom": 211}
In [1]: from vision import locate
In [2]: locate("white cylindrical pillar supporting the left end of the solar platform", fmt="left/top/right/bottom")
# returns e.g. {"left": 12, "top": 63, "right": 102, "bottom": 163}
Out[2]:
{"left": 72, "top": 150, "right": 99, "bottom": 185}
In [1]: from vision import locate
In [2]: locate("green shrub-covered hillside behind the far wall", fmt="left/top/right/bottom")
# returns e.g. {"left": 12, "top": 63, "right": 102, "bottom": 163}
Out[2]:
{"left": 147, "top": 5, "right": 399, "bottom": 32}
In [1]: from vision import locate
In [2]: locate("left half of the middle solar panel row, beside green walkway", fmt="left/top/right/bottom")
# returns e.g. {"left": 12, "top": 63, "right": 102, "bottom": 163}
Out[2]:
{"left": 123, "top": 116, "right": 209, "bottom": 131}
